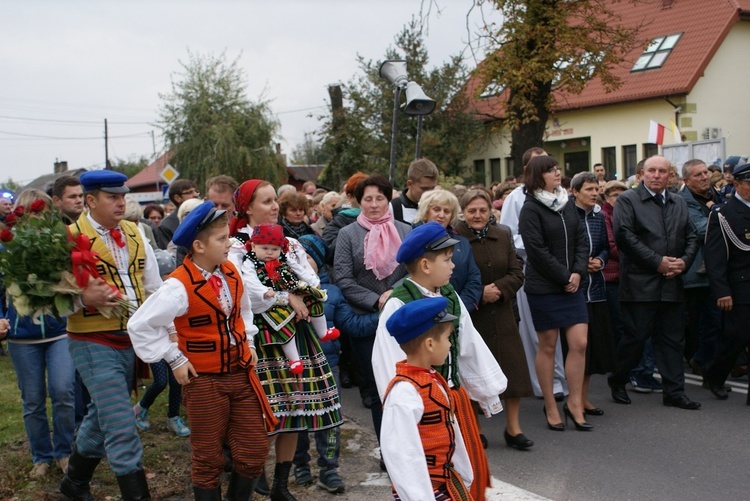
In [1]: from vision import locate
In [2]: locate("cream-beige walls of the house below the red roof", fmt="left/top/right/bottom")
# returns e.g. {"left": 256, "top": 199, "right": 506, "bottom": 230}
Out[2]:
{"left": 466, "top": 22, "right": 750, "bottom": 185}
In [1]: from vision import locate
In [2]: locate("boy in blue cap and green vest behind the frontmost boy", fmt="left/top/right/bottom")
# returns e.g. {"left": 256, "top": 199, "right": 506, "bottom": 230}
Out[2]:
{"left": 372, "top": 221, "right": 508, "bottom": 501}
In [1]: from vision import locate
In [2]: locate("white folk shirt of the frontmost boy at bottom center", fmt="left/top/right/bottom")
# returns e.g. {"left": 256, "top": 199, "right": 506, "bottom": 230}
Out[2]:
{"left": 380, "top": 378, "right": 474, "bottom": 501}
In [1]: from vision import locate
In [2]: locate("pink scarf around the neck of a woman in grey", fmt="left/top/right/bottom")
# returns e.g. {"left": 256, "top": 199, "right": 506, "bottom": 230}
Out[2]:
{"left": 357, "top": 211, "right": 401, "bottom": 280}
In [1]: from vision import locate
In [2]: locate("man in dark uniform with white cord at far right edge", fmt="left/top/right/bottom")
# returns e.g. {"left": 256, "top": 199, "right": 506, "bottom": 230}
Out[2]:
{"left": 703, "top": 164, "right": 750, "bottom": 405}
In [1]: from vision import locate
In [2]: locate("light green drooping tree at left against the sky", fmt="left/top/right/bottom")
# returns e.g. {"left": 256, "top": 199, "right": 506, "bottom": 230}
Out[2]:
{"left": 159, "top": 53, "right": 286, "bottom": 186}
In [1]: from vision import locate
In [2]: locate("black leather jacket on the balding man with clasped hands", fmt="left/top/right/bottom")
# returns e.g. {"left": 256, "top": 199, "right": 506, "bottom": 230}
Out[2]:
{"left": 613, "top": 183, "right": 698, "bottom": 302}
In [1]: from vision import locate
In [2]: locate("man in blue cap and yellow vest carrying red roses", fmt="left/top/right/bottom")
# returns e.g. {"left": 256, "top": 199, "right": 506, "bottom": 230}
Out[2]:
{"left": 60, "top": 170, "right": 161, "bottom": 500}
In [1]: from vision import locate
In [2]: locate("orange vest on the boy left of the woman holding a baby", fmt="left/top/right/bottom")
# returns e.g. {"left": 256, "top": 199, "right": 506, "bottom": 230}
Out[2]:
{"left": 169, "top": 256, "right": 251, "bottom": 374}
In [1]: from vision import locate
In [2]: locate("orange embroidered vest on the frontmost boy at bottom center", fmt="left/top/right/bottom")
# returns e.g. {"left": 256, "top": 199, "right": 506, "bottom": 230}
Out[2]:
{"left": 383, "top": 360, "right": 468, "bottom": 499}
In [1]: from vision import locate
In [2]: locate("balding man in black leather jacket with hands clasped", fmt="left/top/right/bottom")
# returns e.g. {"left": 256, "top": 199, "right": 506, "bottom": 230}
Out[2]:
{"left": 609, "top": 156, "right": 701, "bottom": 409}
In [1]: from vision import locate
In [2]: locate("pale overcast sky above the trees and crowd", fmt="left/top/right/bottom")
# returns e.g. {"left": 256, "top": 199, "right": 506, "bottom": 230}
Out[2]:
{"left": 0, "top": 0, "right": 500, "bottom": 182}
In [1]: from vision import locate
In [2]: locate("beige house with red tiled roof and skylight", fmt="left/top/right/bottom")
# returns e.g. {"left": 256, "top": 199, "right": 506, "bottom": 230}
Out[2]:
{"left": 465, "top": 0, "right": 750, "bottom": 185}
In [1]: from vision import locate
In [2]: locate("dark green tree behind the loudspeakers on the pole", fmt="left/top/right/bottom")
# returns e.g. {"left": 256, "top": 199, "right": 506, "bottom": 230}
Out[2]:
{"left": 319, "top": 20, "right": 483, "bottom": 187}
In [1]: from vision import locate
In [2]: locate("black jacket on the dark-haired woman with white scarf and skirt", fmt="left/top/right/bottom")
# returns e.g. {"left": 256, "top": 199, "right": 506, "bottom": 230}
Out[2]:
{"left": 518, "top": 194, "right": 589, "bottom": 294}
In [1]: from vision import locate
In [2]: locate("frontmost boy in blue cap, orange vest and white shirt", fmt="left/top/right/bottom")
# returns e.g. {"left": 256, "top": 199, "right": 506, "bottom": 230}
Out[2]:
{"left": 380, "top": 297, "right": 473, "bottom": 501}
